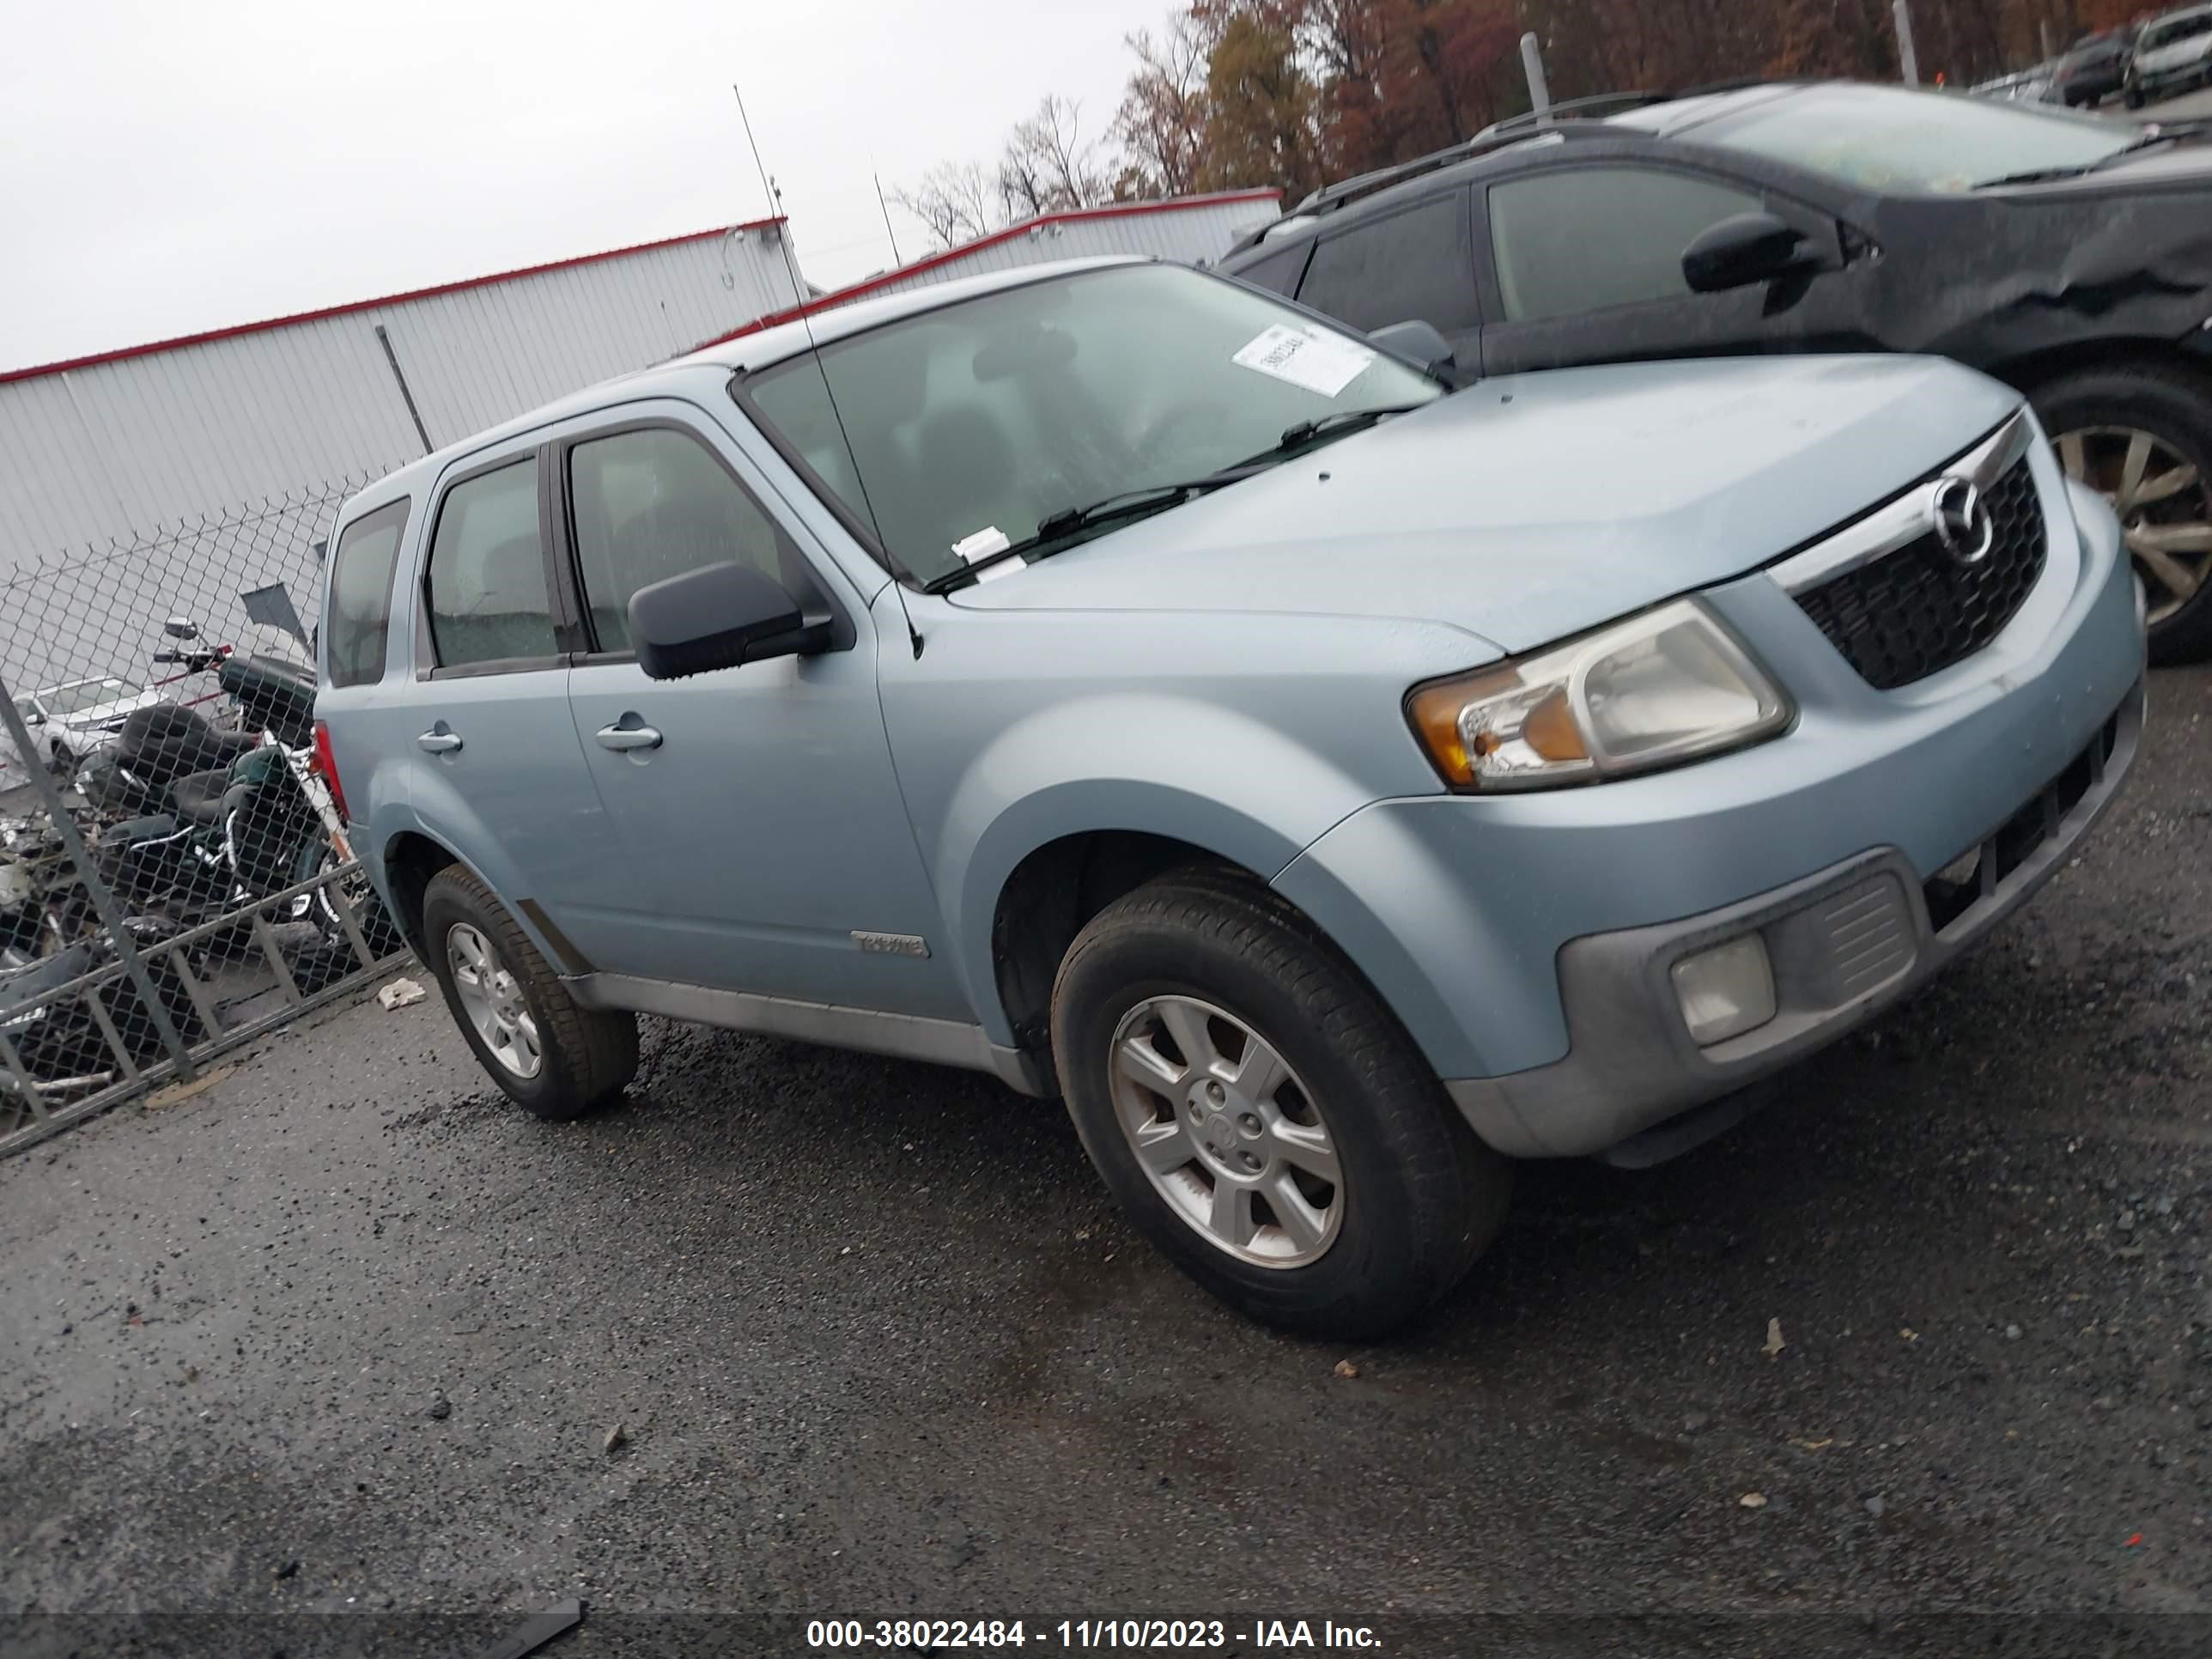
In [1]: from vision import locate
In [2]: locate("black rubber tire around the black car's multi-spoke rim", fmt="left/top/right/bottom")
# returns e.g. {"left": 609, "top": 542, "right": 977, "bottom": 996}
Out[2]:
{"left": 2031, "top": 361, "right": 2212, "bottom": 665}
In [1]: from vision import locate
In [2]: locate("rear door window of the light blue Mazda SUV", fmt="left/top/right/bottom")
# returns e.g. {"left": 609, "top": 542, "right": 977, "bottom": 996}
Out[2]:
{"left": 429, "top": 456, "right": 560, "bottom": 668}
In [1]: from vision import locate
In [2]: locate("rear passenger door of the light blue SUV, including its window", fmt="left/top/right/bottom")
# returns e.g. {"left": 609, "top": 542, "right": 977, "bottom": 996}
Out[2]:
{"left": 391, "top": 438, "right": 630, "bottom": 971}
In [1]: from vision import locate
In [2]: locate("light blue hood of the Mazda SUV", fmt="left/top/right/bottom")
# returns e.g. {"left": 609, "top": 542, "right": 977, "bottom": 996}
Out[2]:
{"left": 953, "top": 356, "right": 2020, "bottom": 653}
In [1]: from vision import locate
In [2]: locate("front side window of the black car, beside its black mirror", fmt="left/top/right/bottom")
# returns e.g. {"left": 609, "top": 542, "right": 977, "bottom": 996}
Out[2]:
{"left": 1491, "top": 168, "right": 1760, "bottom": 323}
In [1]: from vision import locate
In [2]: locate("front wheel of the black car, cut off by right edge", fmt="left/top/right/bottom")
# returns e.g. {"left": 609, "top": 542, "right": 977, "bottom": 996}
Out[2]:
{"left": 2035, "top": 362, "right": 2212, "bottom": 664}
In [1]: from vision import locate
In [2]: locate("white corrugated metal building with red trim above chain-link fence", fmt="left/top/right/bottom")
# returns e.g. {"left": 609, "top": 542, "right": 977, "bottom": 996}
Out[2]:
{"left": 0, "top": 219, "right": 811, "bottom": 568}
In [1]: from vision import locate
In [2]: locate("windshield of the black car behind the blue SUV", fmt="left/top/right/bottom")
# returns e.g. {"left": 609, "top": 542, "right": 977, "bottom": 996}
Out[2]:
{"left": 1694, "top": 86, "right": 2143, "bottom": 195}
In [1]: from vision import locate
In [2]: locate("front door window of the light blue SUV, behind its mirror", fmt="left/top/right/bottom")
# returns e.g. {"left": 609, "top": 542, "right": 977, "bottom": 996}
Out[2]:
{"left": 568, "top": 427, "right": 803, "bottom": 650}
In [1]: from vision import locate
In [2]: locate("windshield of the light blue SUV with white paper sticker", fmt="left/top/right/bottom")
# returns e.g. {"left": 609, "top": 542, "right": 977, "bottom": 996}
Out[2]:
{"left": 738, "top": 265, "right": 1443, "bottom": 581}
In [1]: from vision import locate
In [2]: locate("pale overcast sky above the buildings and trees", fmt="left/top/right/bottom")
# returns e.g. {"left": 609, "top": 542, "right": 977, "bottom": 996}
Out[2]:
{"left": 0, "top": 0, "right": 1168, "bottom": 369}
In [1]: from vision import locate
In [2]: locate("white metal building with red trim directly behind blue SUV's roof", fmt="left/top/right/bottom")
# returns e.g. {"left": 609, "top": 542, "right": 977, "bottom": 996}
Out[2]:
{"left": 699, "top": 191, "right": 1283, "bottom": 341}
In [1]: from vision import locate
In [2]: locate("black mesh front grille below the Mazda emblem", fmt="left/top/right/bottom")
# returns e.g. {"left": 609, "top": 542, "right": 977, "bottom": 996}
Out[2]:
{"left": 1796, "top": 456, "right": 2048, "bottom": 690}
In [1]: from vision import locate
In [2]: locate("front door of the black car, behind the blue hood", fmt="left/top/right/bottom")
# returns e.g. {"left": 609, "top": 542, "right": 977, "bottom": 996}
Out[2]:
{"left": 1475, "top": 159, "right": 1871, "bottom": 374}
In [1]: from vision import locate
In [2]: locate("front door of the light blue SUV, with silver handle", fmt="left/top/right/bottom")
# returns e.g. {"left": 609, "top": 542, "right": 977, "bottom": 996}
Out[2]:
{"left": 556, "top": 400, "right": 973, "bottom": 1020}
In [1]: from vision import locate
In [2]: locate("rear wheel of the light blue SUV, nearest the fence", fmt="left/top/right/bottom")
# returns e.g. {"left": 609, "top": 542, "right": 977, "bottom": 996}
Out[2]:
{"left": 422, "top": 865, "right": 637, "bottom": 1119}
